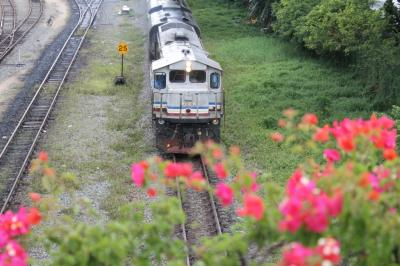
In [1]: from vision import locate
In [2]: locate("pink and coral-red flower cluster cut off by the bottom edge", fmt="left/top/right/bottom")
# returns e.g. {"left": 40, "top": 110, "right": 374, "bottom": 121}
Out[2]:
{"left": 281, "top": 238, "right": 340, "bottom": 266}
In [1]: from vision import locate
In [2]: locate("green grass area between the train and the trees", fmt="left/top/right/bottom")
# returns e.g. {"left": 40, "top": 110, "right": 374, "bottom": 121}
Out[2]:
{"left": 189, "top": 0, "right": 372, "bottom": 182}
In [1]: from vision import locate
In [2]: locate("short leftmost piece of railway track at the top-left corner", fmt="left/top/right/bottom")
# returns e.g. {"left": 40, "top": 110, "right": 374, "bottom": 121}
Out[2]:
{"left": 0, "top": 0, "right": 16, "bottom": 42}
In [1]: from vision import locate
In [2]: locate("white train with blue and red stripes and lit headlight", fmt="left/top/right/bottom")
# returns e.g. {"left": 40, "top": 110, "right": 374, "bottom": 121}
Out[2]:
{"left": 147, "top": 0, "right": 225, "bottom": 154}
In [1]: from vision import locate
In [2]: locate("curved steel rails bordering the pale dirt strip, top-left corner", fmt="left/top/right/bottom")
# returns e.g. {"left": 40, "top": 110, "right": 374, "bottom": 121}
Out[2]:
{"left": 0, "top": 0, "right": 43, "bottom": 62}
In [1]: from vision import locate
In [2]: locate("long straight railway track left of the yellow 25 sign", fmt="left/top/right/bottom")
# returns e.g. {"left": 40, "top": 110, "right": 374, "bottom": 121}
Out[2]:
{"left": 0, "top": 0, "right": 103, "bottom": 213}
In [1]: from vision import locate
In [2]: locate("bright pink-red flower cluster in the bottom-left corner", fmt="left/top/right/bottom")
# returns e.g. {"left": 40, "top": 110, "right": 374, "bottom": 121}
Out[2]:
{"left": 0, "top": 208, "right": 41, "bottom": 266}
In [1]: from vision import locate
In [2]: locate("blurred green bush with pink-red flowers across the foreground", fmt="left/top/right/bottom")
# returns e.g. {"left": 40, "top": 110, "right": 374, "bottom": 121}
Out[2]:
{"left": 21, "top": 109, "right": 400, "bottom": 266}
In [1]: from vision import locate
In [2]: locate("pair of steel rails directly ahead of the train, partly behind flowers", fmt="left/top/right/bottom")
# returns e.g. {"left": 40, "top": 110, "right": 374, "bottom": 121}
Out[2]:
{"left": 173, "top": 155, "right": 222, "bottom": 266}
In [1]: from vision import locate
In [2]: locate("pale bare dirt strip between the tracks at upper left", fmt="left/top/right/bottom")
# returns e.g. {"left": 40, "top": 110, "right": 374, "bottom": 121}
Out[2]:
{"left": 0, "top": 0, "right": 70, "bottom": 120}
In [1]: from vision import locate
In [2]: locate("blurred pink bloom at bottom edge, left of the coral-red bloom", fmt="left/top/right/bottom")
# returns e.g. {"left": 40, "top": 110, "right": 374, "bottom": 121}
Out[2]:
{"left": 283, "top": 243, "right": 314, "bottom": 266}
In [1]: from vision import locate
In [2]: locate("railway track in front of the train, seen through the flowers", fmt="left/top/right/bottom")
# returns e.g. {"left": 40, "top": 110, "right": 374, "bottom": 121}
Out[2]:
{"left": 173, "top": 156, "right": 227, "bottom": 266}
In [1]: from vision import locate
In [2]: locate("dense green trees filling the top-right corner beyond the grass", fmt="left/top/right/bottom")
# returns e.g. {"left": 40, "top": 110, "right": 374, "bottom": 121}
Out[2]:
{"left": 219, "top": 0, "right": 400, "bottom": 110}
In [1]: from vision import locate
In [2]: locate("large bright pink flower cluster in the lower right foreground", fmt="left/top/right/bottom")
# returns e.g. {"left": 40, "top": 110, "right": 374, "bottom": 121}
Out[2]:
{"left": 279, "top": 170, "right": 343, "bottom": 233}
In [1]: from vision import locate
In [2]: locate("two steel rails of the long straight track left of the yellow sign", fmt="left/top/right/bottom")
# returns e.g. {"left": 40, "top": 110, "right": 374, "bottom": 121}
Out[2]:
{"left": 0, "top": 0, "right": 103, "bottom": 213}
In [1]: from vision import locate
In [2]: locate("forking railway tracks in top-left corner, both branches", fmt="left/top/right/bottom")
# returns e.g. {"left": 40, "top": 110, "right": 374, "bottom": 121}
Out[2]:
{"left": 0, "top": 0, "right": 43, "bottom": 62}
